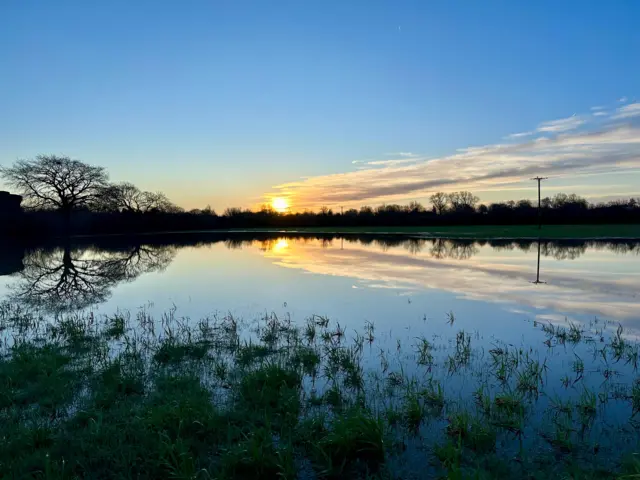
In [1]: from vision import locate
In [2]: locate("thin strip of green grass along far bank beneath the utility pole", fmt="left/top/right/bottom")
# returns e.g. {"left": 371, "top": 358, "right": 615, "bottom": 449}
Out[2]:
{"left": 229, "top": 225, "right": 640, "bottom": 240}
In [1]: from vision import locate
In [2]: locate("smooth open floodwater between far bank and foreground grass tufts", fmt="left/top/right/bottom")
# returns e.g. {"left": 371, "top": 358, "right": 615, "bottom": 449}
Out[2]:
{"left": 0, "top": 234, "right": 640, "bottom": 342}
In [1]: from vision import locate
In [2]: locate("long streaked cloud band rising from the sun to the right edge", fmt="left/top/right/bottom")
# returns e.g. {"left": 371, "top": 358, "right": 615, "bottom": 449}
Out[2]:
{"left": 268, "top": 103, "right": 640, "bottom": 209}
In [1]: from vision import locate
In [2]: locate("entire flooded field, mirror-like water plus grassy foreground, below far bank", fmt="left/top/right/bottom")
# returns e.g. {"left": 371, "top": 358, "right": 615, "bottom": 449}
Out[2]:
{"left": 0, "top": 235, "right": 640, "bottom": 478}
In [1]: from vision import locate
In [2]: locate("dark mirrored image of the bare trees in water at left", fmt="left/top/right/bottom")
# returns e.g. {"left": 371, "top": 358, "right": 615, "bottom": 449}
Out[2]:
{"left": 10, "top": 245, "right": 176, "bottom": 313}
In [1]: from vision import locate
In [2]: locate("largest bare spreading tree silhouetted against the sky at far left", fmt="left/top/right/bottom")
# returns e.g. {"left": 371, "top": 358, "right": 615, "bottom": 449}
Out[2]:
{"left": 0, "top": 155, "right": 108, "bottom": 214}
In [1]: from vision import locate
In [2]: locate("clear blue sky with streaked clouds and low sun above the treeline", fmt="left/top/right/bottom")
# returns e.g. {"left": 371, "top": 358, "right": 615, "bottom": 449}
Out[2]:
{"left": 0, "top": 0, "right": 640, "bottom": 210}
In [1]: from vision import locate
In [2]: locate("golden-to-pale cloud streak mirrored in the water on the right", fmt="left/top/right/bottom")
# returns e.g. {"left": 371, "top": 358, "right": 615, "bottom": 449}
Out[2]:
{"left": 251, "top": 239, "right": 640, "bottom": 328}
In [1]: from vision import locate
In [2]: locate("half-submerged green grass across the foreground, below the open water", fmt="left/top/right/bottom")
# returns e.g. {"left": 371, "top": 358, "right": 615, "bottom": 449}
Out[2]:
{"left": 0, "top": 305, "right": 640, "bottom": 480}
